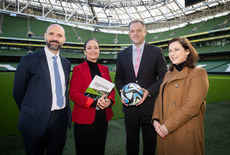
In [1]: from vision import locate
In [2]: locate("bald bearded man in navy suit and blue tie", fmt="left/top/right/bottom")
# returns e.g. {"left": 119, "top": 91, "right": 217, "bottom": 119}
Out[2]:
{"left": 13, "top": 24, "right": 71, "bottom": 155}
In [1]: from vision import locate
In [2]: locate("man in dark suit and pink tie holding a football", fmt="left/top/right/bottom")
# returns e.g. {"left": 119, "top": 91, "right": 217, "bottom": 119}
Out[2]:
{"left": 115, "top": 20, "right": 167, "bottom": 155}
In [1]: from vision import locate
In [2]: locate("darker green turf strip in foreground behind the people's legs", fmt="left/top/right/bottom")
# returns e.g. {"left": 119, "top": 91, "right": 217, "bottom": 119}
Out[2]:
{"left": 0, "top": 100, "right": 230, "bottom": 155}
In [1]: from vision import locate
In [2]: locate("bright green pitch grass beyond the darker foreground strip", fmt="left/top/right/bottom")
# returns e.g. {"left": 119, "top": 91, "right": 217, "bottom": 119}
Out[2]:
{"left": 0, "top": 72, "right": 230, "bottom": 137}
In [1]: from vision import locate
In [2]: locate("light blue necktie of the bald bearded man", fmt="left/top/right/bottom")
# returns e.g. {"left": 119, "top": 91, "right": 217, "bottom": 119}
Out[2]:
{"left": 52, "top": 55, "right": 63, "bottom": 108}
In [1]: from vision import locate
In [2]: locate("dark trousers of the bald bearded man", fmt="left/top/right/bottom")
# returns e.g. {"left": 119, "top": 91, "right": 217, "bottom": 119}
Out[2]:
{"left": 22, "top": 108, "right": 68, "bottom": 155}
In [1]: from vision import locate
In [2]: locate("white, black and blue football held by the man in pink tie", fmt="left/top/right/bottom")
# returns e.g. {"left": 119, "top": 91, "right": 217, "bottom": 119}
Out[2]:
{"left": 121, "top": 83, "right": 143, "bottom": 106}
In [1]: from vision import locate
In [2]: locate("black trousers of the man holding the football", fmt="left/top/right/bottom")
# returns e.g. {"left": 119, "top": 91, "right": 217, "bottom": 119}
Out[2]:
{"left": 125, "top": 111, "right": 156, "bottom": 155}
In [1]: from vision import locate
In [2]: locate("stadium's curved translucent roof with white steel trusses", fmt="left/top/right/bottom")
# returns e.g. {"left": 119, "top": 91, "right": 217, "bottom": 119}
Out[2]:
{"left": 0, "top": 0, "right": 230, "bottom": 33}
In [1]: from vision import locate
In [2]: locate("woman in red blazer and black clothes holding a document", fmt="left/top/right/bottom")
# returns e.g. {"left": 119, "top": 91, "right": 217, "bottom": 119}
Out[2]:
{"left": 69, "top": 39, "right": 115, "bottom": 155}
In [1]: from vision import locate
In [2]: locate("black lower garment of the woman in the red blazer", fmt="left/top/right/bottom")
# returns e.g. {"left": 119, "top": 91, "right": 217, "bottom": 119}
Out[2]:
{"left": 74, "top": 112, "right": 108, "bottom": 155}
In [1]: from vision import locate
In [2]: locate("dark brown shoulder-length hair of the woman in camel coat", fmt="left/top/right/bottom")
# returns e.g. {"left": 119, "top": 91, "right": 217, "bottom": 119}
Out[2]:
{"left": 168, "top": 37, "right": 199, "bottom": 71}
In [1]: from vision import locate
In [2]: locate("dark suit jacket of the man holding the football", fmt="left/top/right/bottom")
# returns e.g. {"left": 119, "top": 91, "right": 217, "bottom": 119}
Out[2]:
{"left": 115, "top": 43, "right": 167, "bottom": 116}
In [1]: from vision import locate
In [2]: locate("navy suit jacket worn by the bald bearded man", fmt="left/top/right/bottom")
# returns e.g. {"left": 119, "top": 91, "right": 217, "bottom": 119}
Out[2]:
{"left": 13, "top": 49, "right": 71, "bottom": 137}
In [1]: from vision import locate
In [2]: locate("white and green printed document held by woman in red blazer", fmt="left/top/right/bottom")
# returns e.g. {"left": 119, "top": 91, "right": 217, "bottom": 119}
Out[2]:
{"left": 85, "top": 75, "right": 114, "bottom": 100}
